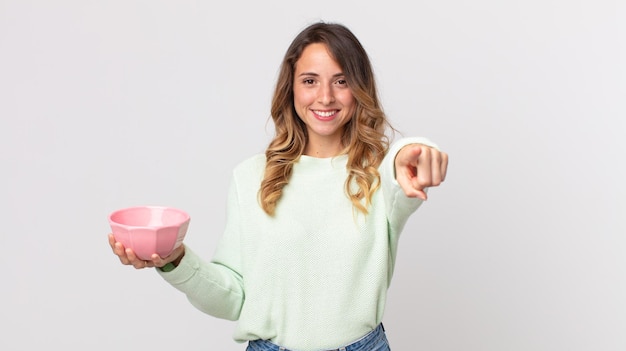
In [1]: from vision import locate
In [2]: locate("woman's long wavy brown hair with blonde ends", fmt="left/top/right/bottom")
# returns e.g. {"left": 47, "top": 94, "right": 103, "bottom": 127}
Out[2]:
{"left": 259, "top": 22, "right": 394, "bottom": 215}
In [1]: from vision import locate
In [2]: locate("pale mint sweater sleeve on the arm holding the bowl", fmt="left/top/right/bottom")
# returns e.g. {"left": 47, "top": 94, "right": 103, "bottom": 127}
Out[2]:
{"left": 157, "top": 179, "right": 245, "bottom": 320}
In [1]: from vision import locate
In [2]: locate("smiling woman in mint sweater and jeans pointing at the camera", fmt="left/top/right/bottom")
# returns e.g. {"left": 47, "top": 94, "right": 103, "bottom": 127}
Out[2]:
{"left": 109, "top": 23, "right": 448, "bottom": 351}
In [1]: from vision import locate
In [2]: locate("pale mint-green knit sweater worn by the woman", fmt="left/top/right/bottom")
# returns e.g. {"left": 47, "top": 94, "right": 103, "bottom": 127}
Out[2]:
{"left": 159, "top": 138, "right": 436, "bottom": 351}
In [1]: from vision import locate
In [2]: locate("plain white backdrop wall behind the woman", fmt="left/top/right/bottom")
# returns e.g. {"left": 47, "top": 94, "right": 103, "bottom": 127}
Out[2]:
{"left": 0, "top": 0, "right": 626, "bottom": 351}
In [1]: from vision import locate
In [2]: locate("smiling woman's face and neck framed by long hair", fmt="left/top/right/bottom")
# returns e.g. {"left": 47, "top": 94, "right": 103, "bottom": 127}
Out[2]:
{"left": 293, "top": 43, "right": 355, "bottom": 156}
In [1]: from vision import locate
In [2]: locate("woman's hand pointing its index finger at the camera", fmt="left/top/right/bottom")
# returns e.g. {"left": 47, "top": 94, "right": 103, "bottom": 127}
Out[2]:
{"left": 395, "top": 144, "right": 448, "bottom": 200}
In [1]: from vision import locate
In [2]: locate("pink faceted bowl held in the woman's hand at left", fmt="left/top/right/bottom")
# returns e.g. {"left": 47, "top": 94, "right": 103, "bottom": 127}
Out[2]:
{"left": 109, "top": 206, "right": 190, "bottom": 260}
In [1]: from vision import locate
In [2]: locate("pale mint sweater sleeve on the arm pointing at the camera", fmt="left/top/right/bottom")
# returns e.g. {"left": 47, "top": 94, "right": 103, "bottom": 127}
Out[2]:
{"left": 380, "top": 137, "right": 438, "bottom": 237}
